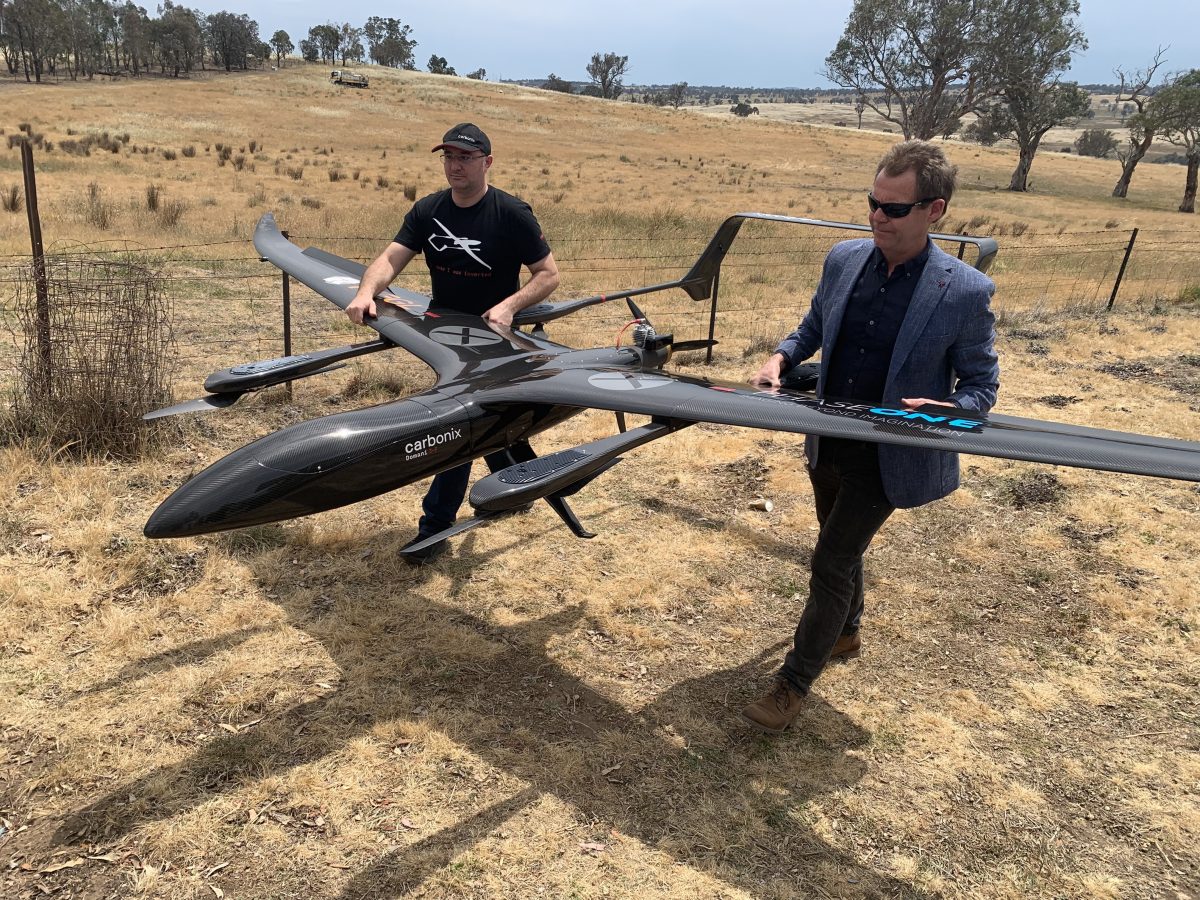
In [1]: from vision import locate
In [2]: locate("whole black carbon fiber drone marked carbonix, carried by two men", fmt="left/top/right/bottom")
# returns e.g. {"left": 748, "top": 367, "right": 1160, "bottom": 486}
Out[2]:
{"left": 145, "top": 212, "right": 1200, "bottom": 552}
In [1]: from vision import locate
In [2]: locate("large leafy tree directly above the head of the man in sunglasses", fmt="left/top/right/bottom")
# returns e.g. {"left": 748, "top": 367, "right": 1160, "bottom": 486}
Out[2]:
{"left": 824, "top": 0, "right": 996, "bottom": 140}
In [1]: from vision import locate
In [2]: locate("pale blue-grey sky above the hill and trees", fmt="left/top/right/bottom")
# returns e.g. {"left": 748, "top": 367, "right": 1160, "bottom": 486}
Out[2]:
{"left": 201, "top": 0, "right": 1200, "bottom": 88}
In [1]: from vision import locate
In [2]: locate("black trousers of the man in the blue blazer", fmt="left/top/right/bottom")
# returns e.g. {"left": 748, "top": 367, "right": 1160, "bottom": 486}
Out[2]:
{"left": 781, "top": 438, "right": 895, "bottom": 694}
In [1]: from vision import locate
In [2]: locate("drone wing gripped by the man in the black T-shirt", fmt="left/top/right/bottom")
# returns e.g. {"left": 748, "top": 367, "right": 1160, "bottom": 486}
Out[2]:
{"left": 254, "top": 212, "right": 557, "bottom": 384}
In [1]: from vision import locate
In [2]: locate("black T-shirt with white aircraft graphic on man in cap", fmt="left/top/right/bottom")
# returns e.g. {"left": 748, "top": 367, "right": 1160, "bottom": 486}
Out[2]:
{"left": 395, "top": 186, "right": 550, "bottom": 316}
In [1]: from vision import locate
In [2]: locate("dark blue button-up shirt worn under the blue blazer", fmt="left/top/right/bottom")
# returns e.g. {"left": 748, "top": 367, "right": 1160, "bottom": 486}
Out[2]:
{"left": 824, "top": 242, "right": 929, "bottom": 403}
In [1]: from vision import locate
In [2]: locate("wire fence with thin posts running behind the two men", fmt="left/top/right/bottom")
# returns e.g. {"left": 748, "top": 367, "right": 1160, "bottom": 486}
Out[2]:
{"left": 0, "top": 222, "right": 1200, "bottom": 393}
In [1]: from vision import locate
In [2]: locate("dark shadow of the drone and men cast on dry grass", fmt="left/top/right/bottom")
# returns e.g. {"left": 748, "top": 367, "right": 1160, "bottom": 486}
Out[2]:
{"left": 54, "top": 535, "right": 929, "bottom": 900}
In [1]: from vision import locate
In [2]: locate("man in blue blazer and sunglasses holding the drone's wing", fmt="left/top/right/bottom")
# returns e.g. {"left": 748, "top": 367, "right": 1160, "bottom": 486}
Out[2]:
{"left": 742, "top": 140, "right": 1000, "bottom": 734}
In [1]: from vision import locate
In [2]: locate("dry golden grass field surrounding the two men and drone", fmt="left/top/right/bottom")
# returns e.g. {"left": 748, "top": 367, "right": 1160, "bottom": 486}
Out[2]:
{"left": 0, "top": 68, "right": 1200, "bottom": 900}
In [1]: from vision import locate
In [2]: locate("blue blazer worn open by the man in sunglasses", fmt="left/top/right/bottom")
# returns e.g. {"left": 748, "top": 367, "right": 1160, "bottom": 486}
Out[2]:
{"left": 776, "top": 238, "right": 1000, "bottom": 509}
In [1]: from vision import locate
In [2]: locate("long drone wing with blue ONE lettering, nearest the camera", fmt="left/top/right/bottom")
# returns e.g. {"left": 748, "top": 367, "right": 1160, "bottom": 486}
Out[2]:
{"left": 486, "top": 368, "right": 1200, "bottom": 481}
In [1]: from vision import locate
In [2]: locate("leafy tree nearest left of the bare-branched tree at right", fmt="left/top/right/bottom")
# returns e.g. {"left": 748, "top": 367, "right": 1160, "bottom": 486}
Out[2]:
{"left": 964, "top": 0, "right": 1091, "bottom": 191}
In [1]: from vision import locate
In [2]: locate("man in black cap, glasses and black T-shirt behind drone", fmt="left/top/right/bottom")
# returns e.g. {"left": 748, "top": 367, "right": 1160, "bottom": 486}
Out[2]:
{"left": 346, "top": 122, "right": 558, "bottom": 563}
